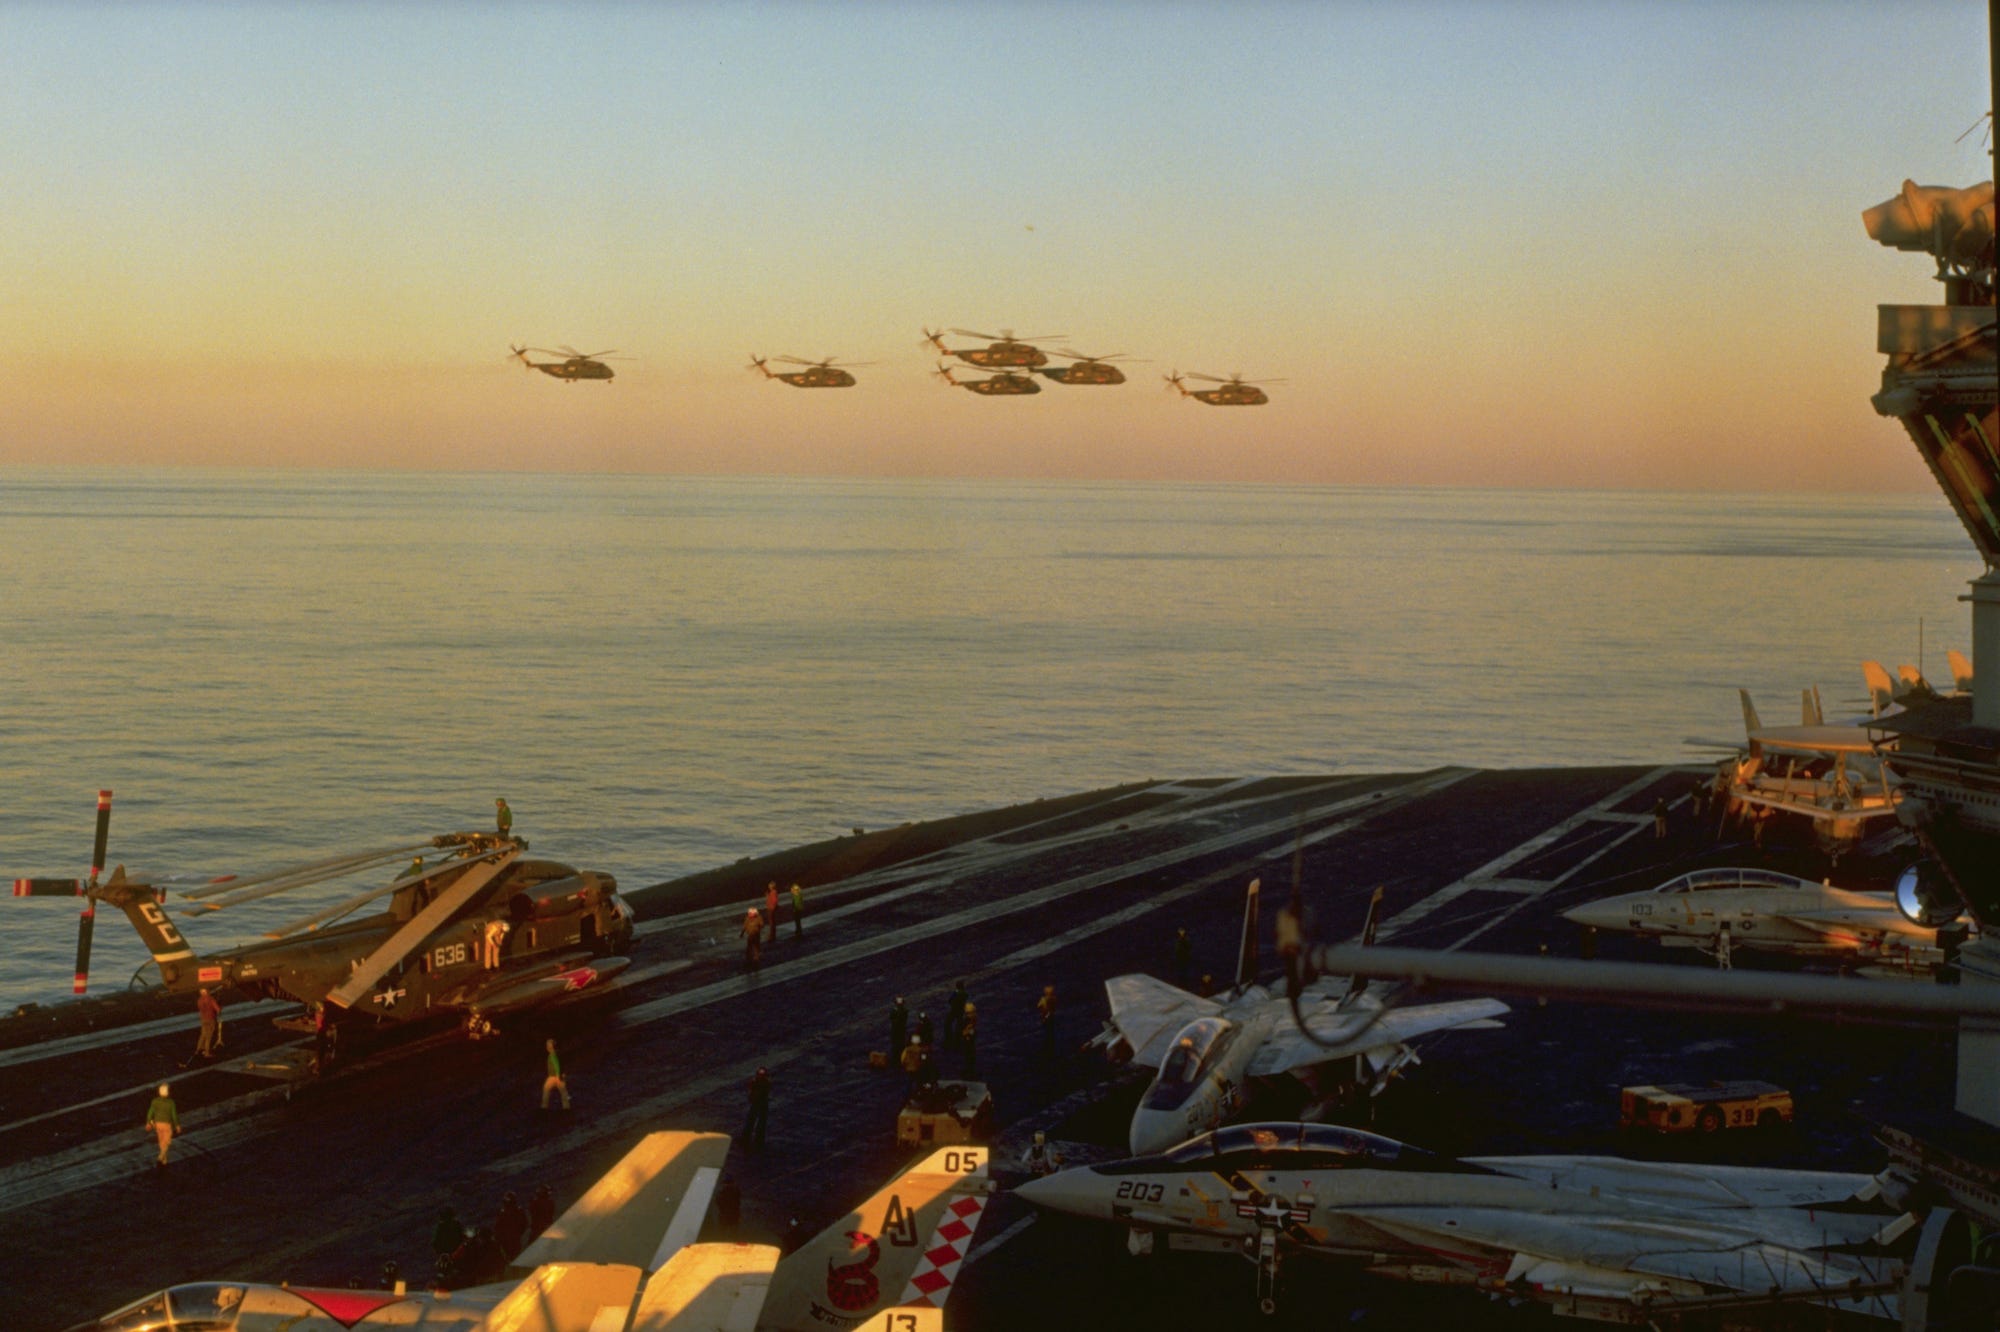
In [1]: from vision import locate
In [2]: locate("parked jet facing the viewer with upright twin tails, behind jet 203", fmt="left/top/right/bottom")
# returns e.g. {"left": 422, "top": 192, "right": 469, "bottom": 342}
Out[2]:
{"left": 1100, "top": 880, "right": 1508, "bottom": 1152}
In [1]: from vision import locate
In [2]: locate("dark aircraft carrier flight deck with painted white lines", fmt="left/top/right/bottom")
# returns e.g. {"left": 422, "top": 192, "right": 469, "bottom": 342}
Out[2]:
{"left": 0, "top": 764, "right": 1952, "bottom": 1332}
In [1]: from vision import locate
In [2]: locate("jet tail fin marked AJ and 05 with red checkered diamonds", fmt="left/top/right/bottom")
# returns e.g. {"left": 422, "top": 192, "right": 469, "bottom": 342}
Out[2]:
{"left": 758, "top": 1146, "right": 992, "bottom": 1332}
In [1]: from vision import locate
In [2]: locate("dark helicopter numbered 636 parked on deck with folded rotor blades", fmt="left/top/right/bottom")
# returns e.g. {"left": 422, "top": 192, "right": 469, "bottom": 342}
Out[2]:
{"left": 14, "top": 790, "right": 632, "bottom": 1036}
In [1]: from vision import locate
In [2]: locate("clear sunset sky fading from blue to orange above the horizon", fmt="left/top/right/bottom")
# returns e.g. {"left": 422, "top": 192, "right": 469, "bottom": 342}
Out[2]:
{"left": 0, "top": 0, "right": 1992, "bottom": 490}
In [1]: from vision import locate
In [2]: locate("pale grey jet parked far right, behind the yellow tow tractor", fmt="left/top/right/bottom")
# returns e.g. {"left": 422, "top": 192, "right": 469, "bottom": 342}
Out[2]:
{"left": 1562, "top": 868, "right": 1968, "bottom": 970}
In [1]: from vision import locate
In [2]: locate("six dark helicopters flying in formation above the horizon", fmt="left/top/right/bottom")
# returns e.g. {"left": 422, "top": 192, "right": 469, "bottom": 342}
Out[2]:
{"left": 528, "top": 328, "right": 1284, "bottom": 406}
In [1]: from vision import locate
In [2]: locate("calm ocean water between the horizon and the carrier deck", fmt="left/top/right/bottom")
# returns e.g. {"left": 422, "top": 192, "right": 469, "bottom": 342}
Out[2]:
{"left": 0, "top": 470, "right": 1978, "bottom": 1006}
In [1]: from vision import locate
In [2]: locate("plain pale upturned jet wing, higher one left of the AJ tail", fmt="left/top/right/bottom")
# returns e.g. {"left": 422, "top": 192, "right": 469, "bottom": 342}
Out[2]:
{"left": 510, "top": 1132, "right": 730, "bottom": 1272}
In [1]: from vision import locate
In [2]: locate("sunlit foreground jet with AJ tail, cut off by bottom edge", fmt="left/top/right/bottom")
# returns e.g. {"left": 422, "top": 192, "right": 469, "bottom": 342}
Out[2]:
{"left": 78, "top": 1132, "right": 992, "bottom": 1332}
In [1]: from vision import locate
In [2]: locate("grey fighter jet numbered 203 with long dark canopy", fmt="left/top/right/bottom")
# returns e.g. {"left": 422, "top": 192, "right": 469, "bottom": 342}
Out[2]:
{"left": 1014, "top": 1124, "right": 1916, "bottom": 1322}
